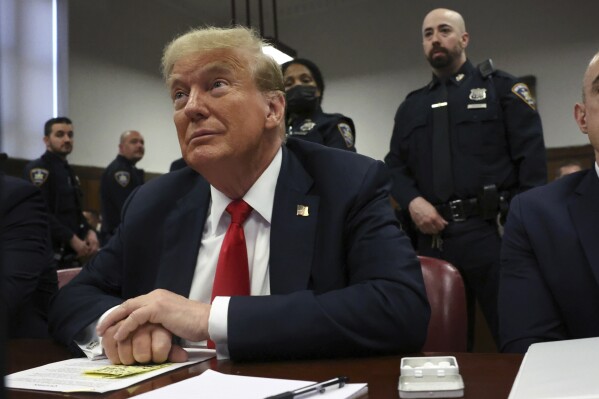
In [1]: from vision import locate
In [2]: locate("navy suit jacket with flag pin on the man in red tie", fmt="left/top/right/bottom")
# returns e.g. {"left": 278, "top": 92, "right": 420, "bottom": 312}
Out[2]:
{"left": 50, "top": 139, "right": 430, "bottom": 359}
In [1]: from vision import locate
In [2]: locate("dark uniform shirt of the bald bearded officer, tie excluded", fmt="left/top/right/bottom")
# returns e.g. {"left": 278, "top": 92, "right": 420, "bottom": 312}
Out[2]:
{"left": 385, "top": 61, "right": 547, "bottom": 209}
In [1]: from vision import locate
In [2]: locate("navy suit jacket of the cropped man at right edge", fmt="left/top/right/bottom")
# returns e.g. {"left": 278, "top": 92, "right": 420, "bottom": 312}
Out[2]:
{"left": 499, "top": 168, "right": 599, "bottom": 352}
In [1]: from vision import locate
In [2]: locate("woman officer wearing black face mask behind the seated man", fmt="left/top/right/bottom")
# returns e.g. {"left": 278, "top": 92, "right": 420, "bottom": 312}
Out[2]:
{"left": 282, "top": 58, "right": 356, "bottom": 152}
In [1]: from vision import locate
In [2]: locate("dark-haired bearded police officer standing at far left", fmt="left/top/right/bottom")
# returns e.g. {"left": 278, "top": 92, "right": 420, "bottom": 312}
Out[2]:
{"left": 24, "top": 117, "right": 99, "bottom": 268}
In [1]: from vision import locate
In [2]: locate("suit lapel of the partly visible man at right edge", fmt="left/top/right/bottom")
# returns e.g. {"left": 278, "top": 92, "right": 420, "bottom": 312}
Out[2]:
{"left": 568, "top": 168, "right": 599, "bottom": 282}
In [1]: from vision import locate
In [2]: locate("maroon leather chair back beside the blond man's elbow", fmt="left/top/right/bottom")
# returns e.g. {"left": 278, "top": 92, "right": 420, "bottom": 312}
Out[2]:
{"left": 418, "top": 256, "right": 468, "bottom": 352}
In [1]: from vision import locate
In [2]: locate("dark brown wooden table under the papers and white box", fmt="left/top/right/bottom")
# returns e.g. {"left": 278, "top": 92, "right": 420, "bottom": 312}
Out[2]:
{"left": 7, "top": 340, "right": 522, "bottom": 399}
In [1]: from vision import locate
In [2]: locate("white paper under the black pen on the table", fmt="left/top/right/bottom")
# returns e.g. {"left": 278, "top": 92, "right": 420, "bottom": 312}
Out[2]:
{"left": 136, "top": 370, "right": 368, "bottom": 399}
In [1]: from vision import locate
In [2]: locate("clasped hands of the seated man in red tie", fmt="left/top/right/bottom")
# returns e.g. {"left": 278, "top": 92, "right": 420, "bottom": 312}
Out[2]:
{"left": 96, "top": 289, "right": 210, "bottom": 364}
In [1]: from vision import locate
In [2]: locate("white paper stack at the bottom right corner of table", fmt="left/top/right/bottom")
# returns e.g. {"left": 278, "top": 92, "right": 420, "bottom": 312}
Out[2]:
{"left": 509, "top": 338, "right": 599, "bottom": 399}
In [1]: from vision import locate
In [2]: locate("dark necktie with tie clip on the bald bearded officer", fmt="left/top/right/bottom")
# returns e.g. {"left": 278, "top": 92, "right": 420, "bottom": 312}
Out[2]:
{"left": 431, "top": 82, "right": 453, "bottom": 202}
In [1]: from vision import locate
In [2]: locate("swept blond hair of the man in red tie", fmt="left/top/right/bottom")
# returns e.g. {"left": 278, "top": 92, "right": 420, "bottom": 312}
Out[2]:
{"left": 162, "top": 26, "right": 285, "bottom": 92}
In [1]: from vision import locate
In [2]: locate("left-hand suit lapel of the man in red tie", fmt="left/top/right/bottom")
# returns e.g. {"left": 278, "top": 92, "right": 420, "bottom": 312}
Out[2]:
{"left": 156, "top": 171, "right": 210, "bottom": 296}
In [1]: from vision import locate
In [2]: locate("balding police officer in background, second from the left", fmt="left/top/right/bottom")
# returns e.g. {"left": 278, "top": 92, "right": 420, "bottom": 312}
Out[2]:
{"left": 100, "top": 130, "right": 145, "bottom": 241}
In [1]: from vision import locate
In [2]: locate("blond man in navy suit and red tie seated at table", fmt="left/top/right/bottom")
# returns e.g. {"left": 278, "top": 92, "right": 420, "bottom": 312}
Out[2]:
{"left": 50, "top": 27, "right": 430, "bottom": 364}
